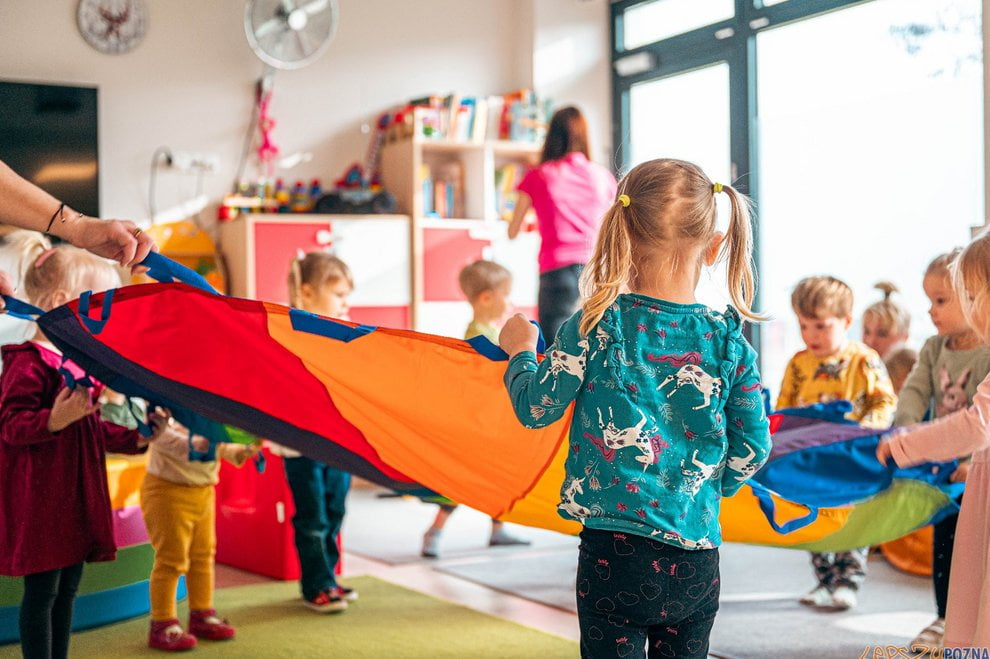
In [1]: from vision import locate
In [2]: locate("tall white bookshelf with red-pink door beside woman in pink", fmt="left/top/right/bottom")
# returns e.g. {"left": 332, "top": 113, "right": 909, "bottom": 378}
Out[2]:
{"left": 381, "top": 111, "right": 542, "bottom": 336}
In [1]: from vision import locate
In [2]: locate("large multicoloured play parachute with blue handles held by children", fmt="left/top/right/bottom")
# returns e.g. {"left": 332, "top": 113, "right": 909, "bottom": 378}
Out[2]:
{"left": 0, "top": 255, "right": 952, "bottom": 550}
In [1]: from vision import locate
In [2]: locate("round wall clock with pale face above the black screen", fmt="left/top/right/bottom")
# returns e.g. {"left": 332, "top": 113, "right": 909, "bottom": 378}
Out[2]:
{"left": 76, "top": 0, "right": 148, "bottom": 55}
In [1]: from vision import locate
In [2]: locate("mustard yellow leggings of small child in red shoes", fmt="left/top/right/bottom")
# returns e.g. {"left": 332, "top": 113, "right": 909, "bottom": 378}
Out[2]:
{"left": 141, "top": 474, "right": 217, "bottom": 620}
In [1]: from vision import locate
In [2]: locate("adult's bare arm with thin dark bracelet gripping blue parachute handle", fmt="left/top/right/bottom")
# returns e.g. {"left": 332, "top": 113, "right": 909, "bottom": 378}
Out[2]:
{"left": 0, "top": 160, "right": 155, "bottom": 266}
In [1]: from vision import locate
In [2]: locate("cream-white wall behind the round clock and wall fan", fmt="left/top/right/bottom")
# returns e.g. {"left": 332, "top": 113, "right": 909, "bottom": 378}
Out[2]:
{"left": 0, "top": 0, "right": 536, "bottom": 226}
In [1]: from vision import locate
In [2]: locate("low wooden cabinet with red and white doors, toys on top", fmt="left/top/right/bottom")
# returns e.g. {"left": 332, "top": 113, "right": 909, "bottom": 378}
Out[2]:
{"left": 220, "top": 214, "right": 412, "bottom": 328}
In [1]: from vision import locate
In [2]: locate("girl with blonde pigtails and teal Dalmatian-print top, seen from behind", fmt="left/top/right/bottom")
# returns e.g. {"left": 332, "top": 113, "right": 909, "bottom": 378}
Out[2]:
{"left": 499, "top": 159, "right": 770, "bottom": 658}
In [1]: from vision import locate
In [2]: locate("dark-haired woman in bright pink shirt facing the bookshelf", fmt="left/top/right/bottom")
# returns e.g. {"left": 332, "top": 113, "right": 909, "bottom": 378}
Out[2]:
{"left": 509, "top": 107, "right": 617, "bottom": 343}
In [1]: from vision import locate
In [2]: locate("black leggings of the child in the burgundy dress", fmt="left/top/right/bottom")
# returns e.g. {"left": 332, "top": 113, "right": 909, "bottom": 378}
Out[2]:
{"left": 20, "top": 563, "right": 82, "bottom": 659}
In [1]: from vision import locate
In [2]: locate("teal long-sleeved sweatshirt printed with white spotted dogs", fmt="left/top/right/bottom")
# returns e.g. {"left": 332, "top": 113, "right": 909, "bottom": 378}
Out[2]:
{"left": 505, "top": 294, "right": 771, "bottom": 549}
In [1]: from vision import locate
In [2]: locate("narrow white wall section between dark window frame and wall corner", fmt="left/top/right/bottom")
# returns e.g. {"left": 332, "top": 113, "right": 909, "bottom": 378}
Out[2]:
{"left": 532, "top": 0, "right": 612, "bottom": 167}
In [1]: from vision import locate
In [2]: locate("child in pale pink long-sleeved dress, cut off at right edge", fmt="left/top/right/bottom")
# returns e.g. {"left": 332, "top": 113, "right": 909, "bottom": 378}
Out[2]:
{"left": 877, "top": 231, "right": 990, "bottom": 649}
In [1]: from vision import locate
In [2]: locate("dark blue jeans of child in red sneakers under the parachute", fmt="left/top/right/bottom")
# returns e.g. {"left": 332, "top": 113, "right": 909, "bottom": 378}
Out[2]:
{"left": 285, "top": 457, "right": 351, "bottom": 599}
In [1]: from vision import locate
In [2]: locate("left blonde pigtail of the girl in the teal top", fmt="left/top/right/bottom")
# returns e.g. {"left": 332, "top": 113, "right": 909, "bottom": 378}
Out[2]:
{"left": 579, "top": 202, "right": 633, "bottom": 336}
